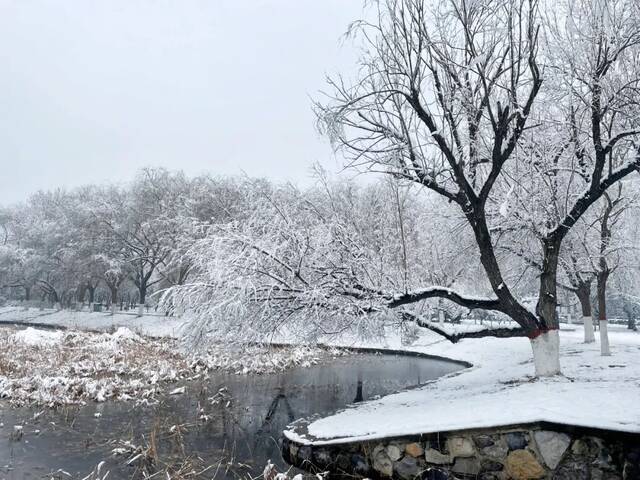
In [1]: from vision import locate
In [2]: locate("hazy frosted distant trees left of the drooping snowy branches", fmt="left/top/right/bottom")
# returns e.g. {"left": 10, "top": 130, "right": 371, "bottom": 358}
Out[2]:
{"left": 0, "top": 169, "right": 248, "bottom": 316}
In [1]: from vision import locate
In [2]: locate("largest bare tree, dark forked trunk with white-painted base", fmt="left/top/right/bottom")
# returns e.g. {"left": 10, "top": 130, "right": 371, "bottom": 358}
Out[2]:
{"left": 317, "top": 0, "right": 640, "bottom": 375}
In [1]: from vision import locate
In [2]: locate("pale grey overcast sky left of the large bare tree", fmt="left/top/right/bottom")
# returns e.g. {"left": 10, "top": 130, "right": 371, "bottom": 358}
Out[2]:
{"left": 0, "top": 0, "right": 362, "bottom": 203}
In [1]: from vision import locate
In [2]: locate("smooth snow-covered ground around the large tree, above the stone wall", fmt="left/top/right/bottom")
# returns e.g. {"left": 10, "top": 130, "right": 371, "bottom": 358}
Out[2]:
{"left": 286, "top": 327, "right": 640, "bottom": 443}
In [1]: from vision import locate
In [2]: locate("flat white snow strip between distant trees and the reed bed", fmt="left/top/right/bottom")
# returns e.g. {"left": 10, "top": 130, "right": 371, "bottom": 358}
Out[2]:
{"left": 0, "top": 307, "right": 185, "bottom": 338}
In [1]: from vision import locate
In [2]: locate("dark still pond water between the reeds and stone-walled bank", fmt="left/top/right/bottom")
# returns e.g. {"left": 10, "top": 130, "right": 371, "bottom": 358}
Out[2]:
{"left": 0, "top": 353, "right": 461, "bottom": 480}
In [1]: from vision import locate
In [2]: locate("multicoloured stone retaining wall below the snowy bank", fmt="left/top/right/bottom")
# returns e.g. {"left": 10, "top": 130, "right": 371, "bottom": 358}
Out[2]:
{"left": 282, "top": 423, "right": 640, "bottom": 480}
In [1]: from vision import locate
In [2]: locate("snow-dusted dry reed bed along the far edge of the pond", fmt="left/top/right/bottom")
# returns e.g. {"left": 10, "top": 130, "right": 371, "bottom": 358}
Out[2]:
{"left": 0, "top": 327, "right": 344, "bottom": 407}
